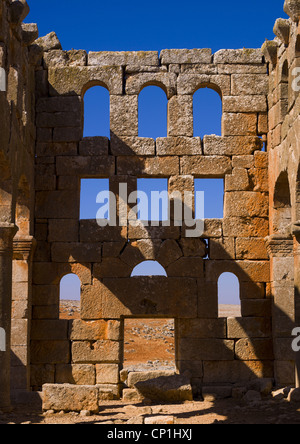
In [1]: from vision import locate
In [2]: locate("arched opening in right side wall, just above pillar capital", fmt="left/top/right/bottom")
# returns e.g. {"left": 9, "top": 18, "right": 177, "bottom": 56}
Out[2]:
{"left": 272, "top": 171, "right": 292, "bottom": 234}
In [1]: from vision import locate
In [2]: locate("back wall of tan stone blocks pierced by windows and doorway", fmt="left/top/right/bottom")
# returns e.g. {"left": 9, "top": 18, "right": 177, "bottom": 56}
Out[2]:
{"left": 31, "top": 34, "right": 274, "bottom": 395}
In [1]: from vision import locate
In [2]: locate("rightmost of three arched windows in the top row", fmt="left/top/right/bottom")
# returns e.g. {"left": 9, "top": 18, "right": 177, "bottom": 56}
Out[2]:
{"left": 193, "top": 88, "right": 222, "bottom": 139}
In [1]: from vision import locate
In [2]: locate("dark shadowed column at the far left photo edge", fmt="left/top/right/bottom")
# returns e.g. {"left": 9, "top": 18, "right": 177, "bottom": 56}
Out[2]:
{"left": 0, "top": 223, "right": 17, "bottom": 411}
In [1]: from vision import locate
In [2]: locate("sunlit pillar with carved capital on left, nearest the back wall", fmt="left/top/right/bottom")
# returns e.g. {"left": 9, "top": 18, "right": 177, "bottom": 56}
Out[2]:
{"left": 11, "top": 235, "right": 36, "bottom": 399}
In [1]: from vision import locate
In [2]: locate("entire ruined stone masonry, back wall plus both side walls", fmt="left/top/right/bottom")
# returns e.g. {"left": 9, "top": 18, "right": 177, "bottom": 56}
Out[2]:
{"left": 0, "top": 0, "right": 300, "bottom": 409}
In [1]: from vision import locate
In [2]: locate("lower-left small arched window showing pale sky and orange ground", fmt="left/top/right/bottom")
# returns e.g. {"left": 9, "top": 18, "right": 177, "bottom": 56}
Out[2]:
{"left": 59, "top": 273, "right": 81, "bottom": 319}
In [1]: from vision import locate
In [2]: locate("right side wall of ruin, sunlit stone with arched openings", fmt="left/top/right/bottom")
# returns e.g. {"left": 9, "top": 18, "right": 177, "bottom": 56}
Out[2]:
{"left": 263, "top": 0, "right": 300, "bottom": 383}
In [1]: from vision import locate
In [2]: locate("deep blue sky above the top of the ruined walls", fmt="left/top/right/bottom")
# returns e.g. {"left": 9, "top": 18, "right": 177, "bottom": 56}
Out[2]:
{"left": 26, "top": 0, "right": 286, "bottom": 51}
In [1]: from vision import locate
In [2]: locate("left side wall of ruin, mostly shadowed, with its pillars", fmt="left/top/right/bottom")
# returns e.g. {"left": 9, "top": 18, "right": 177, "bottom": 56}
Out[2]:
{"left": 0, "top": 0, "right": 38, "bottom": 410}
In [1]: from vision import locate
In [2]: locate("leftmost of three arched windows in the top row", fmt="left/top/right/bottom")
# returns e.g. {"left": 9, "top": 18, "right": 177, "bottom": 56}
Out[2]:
{"left": 83, "top": 86, "right": 110, "bottom": 138}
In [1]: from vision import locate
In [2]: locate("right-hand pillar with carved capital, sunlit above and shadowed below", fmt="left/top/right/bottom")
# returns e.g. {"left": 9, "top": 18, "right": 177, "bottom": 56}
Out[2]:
{"left": 266, "top": 234, "right": 295, "bottom": 385}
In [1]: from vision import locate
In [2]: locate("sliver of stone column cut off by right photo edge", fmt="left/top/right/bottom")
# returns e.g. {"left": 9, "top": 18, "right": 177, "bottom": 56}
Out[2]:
{"left": 292, "top": 221, "right": 300, "bottom": 388}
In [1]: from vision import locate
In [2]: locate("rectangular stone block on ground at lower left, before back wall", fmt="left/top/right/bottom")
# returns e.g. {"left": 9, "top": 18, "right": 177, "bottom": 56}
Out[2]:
{"left": 43, "top": 384, "right": 99, "bottom": 413}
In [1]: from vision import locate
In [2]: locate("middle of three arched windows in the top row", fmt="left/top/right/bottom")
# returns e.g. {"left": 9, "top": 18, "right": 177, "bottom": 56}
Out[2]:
{"left": 139, "top": 86, "right": 168, "bottom": 139}
